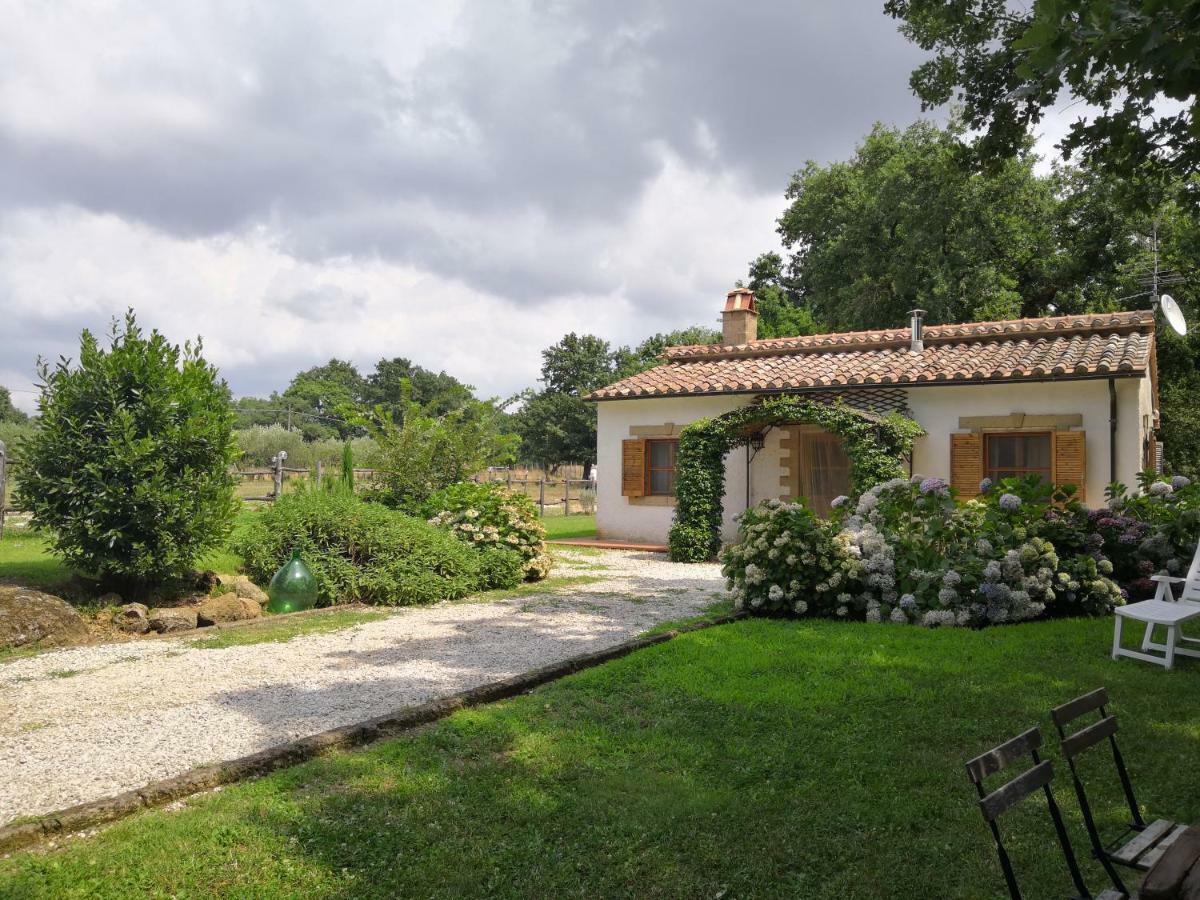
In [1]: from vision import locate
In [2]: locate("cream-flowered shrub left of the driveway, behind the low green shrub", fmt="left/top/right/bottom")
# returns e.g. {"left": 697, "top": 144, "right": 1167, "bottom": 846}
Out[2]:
{"left": 426, "top": 481, "right": 551, "bottom": 587}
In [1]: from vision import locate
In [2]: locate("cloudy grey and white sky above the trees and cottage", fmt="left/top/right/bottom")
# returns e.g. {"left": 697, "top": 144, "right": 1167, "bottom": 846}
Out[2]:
{"left": 0, "top": 0, "right": 950, "bottom": 409}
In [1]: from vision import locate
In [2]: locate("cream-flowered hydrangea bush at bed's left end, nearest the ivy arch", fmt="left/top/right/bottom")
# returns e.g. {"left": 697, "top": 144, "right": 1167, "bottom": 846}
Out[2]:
{"left": 721, "top": 500, "right": 859, "bottom": 616}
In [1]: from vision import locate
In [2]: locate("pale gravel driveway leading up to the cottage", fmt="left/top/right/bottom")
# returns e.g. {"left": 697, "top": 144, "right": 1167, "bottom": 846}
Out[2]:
{"left": 0, "top": 551, "right": 724, "bottom": 824}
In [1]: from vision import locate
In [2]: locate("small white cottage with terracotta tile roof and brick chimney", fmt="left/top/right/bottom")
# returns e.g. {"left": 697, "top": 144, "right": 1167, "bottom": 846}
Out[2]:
{"left": 590, "top": 289, "right": 1158, "bottom": 544}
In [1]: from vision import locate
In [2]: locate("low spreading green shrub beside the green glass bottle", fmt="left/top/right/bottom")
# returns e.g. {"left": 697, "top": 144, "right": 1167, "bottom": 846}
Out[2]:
{"left": 233, "top": 490, "right": 484, "bottom": 606}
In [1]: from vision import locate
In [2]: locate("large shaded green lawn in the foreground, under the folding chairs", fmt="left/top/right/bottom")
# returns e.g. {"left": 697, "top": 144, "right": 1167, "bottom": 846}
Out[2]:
{"left": 0, "top": 620, "right": 1200, "bottom": 899}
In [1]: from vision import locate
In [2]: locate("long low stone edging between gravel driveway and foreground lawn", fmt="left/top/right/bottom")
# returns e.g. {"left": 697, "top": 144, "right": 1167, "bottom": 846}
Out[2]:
{"left": 0, "top": 612, "right": 745, "bottom": 853}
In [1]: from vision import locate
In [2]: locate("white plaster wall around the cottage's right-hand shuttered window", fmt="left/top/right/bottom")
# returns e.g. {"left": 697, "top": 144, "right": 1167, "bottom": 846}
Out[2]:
{"left": 908, "top": 378, "right": 1150, "bottom": 506}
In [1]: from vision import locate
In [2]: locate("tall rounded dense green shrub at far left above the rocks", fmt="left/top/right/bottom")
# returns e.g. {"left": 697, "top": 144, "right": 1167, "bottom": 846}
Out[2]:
{"left": 18, "top": 312, "right": 235, "bottom": 587}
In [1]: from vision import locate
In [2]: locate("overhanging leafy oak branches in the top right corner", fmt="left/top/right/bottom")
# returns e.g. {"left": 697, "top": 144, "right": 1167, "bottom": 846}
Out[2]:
{"left": 884, "top": 0, "right": 1200, "bottom": 199}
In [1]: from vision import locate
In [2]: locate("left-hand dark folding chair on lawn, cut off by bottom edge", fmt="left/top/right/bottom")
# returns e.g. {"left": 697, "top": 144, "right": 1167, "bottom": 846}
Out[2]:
{"left": 967, "top": 728, "right": 1124, "bottom": 900}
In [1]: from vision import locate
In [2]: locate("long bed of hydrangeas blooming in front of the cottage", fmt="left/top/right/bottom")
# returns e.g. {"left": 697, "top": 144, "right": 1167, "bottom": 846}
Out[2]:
{"left": 721, "top": 476, "right": 1200, "bottom": 626}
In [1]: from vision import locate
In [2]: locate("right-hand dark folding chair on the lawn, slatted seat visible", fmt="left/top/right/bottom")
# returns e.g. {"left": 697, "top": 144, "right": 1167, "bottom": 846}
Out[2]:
{"left": 1050, "top": 688, "right": 1187, "bottom": 890}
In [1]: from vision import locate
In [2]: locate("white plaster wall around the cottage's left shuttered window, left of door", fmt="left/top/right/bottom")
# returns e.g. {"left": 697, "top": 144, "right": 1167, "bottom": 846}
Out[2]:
{"left": 596, "top": 395, "right": 753, "bottom": 544}
